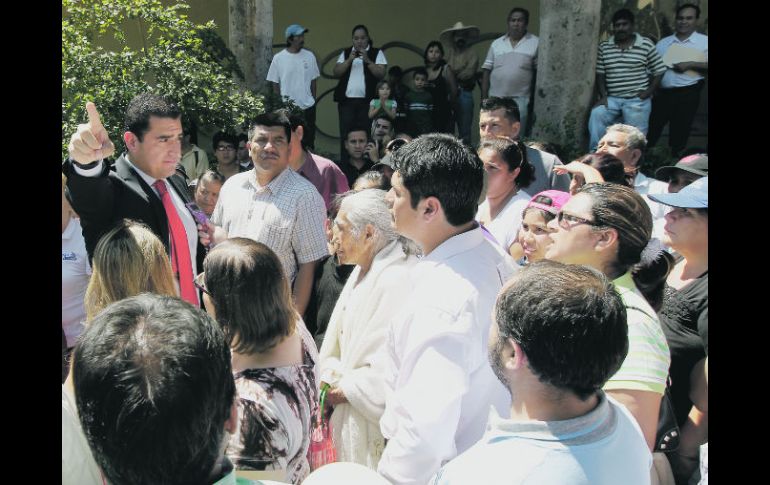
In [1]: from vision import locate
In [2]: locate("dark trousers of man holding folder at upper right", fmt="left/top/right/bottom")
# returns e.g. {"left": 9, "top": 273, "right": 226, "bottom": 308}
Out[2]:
{"left": 647, "top": 81, "right": 703, "bottom": 156}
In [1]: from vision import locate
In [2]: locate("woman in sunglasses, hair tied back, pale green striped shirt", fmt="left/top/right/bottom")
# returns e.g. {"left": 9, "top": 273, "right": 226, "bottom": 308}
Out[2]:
{"left": 545, "top": 183, "right": 670, "bottom": 450}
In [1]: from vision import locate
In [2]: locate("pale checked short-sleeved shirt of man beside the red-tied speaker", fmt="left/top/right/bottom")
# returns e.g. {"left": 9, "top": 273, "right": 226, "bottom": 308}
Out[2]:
{"left": 211, "top": 168, "right": 328, "bottom": 284}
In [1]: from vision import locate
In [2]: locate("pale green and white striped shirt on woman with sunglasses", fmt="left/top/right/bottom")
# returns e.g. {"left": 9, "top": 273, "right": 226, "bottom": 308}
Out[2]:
{"left": 604, "top": 272, "right": 671, "bottom": 394}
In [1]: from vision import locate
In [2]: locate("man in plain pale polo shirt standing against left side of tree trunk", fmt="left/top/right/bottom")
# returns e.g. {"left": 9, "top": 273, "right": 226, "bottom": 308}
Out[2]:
{"left": 481, "top": 7, "right": 540, "bottom": 134}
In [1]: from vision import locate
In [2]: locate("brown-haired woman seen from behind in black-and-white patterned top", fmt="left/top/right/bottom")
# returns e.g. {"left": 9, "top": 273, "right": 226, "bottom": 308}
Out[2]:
{"left": 201, "top": 237, "right": 319, "bottom": 483}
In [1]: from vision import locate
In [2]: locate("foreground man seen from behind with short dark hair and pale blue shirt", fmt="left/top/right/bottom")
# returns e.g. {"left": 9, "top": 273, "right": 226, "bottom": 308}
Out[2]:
{"left": 431, "top": 261, "right": 652, "bottom": 485}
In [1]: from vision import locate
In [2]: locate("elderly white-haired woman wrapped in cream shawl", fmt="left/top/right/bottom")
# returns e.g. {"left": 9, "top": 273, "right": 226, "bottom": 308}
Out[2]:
{"left": 320, "top": 189, "right": 416, "bottom": 469}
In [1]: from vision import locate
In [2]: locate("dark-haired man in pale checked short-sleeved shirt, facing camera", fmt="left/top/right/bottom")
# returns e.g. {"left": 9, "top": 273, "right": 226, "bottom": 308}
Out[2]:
{"left": 201, "top": 111, "right": 327, "bottom": 315}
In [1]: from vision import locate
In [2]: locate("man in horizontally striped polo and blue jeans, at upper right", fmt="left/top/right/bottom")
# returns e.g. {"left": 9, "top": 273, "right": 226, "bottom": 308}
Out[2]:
{"left": 588, "top": 8, "right": 666, "bottom": 151}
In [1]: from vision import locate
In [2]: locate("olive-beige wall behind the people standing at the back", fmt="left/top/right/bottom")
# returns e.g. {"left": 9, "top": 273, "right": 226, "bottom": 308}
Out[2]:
{"left": 146, "top": 0, "right": 708, "bottom": 157}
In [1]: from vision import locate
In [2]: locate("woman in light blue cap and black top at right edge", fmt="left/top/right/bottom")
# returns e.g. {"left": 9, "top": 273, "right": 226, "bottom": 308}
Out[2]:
{"left": 650, "top": 177, "right": 708, "bottom": 481}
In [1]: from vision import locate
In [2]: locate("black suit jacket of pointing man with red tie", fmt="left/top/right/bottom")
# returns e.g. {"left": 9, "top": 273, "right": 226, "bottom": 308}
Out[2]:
{"left": 62, "top": 154, "right": 205, "bottom": 270}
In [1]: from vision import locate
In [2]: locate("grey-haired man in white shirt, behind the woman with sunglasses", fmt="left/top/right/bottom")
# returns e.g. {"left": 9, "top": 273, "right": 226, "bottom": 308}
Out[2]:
{"left": 596, "top": 123, "right": 668, "bottom": 219}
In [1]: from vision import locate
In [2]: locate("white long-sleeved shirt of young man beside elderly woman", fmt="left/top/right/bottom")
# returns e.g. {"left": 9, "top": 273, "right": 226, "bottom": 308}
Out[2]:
{"left": 377, "top": 227, "right": 515, "bottom": 484}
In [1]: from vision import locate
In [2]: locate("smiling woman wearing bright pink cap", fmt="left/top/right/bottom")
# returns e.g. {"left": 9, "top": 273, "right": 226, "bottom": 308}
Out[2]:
{"left": 517, "top": 190, "right": 570, "bottom": 266}
